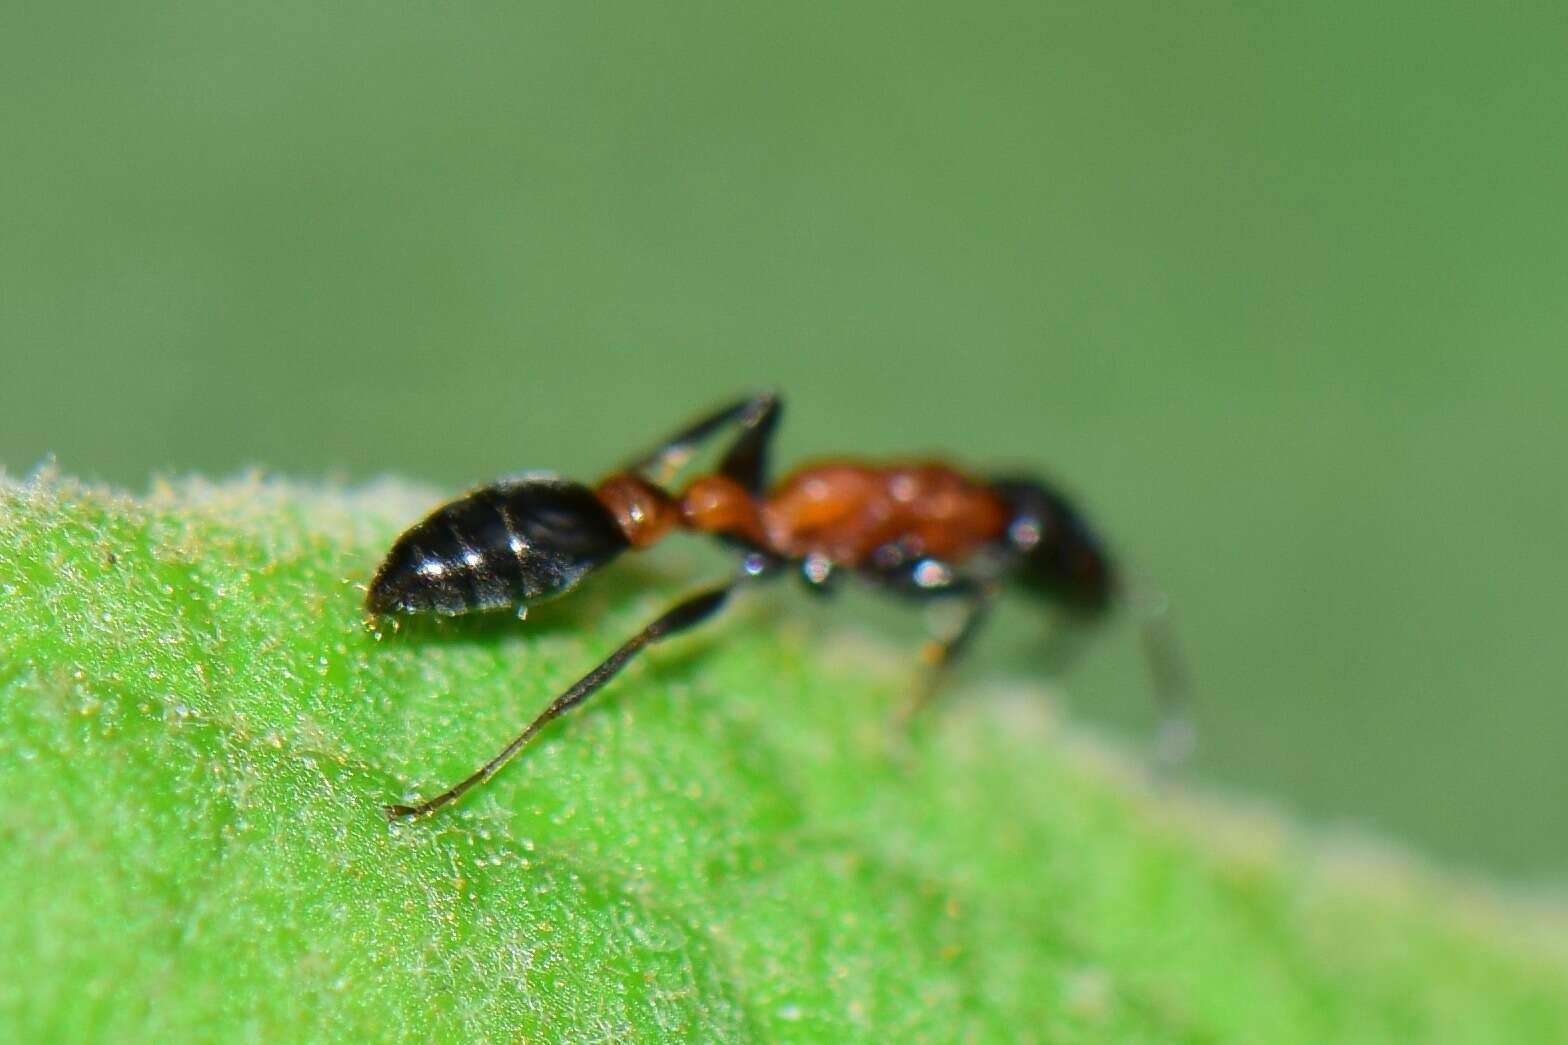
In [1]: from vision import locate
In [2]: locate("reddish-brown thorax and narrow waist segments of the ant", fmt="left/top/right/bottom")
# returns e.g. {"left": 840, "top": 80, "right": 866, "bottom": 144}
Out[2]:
{"left": 596, "top": 461, "right": 1011, "bottom": 566}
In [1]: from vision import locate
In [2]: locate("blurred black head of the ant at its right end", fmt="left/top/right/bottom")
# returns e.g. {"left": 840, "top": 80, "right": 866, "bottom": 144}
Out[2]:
{"left": 991, "top": 479, "right": 1116, "bottom": 614}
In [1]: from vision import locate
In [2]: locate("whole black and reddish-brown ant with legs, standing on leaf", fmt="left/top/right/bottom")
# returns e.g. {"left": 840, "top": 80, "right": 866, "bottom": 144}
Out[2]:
{"left": 365, "top": 392, "right": 1187, "bottom": 817}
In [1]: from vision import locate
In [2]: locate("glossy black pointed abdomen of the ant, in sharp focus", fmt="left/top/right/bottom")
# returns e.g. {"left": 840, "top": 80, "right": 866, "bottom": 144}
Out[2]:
{"left": 365, "top": 475, "right": 627, "bottom": 617}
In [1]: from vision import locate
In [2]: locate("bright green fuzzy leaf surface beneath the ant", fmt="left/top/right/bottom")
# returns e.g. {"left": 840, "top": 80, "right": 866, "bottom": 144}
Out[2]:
{"left": 0, "top": 477, "right": 1568, "bottom": 1042}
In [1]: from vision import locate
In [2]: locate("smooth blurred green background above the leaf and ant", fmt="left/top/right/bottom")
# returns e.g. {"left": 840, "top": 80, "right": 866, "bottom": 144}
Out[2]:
{"left": 0, "top": 0, "right": 1568, "bottom": 880}
